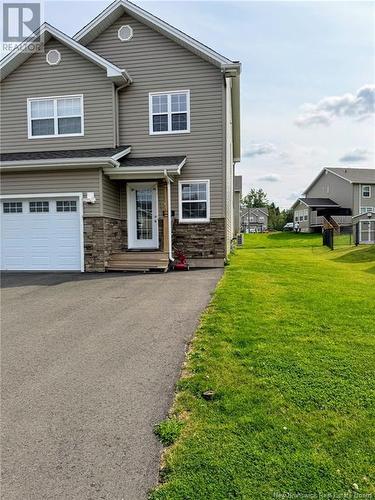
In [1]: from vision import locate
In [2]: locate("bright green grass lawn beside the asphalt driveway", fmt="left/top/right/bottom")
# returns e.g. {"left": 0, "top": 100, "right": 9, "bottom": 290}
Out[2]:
{"left": 151, "top": 233, "right": 375, "bottom": 500}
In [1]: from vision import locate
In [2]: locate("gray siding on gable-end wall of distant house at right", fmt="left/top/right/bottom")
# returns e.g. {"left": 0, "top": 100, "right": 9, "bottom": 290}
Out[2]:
{"left": 306, "top": 172, "right": 353, "bottom": 210}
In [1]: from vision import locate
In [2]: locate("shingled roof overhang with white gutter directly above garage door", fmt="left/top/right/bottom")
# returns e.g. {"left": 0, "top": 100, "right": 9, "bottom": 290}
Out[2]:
{"left": 0, "top": 146, "right": 131, "bottom": 172}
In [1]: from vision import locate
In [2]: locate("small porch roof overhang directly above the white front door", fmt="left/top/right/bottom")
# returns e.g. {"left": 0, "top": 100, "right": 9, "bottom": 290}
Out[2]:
{"left": 104, "top": 156, "right": 186, "bottom": 180}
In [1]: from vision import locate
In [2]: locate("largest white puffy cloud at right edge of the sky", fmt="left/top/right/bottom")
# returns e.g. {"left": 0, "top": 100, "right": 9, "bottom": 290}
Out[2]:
{"left": 294, "top": 84, "right": 375, "bottom": 127}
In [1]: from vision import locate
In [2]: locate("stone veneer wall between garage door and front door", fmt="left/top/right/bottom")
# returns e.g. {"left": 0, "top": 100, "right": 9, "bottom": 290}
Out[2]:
{"left": 83, "top": 217, "right": 127, "bottom": 272}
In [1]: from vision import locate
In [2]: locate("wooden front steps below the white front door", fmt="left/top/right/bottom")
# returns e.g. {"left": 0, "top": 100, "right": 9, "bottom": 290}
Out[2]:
{"left": 106, "top": 252, "right": 169, "bottom": 271}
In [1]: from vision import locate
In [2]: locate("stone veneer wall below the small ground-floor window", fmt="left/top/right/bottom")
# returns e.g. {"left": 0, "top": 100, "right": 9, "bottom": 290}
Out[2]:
{"left": 173, "top": 219, "right": 226, "bottom": 259}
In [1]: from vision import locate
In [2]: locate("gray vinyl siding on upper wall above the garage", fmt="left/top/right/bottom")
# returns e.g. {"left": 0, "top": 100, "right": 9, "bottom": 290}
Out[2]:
{"left": 1, "top": 40, "right": 114, "bottom": 153}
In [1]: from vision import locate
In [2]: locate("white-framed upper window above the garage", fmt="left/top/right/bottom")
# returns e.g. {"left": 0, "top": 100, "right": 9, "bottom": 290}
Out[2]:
{"left": 27, "top": 95, "right": 83, "bottom": 139}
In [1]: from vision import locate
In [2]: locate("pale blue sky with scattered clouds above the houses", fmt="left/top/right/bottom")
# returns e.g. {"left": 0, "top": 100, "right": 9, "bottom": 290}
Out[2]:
{"left": 2, "top": 0, "right": 375, "bottom": 208}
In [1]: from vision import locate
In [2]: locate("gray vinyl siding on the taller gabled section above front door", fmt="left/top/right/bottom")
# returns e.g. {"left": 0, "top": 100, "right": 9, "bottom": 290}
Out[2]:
{"left": 88, "top": 16, "right": 225, "bottom": 217}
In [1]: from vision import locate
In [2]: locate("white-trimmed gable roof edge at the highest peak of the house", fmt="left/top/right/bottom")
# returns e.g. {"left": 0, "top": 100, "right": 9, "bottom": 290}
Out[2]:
{"left": 74, "top": 0, "right": 241, "bottom": 73}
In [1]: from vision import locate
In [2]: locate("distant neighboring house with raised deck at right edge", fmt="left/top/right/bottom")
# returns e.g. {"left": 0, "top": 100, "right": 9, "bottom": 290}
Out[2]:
{"left": 292, "top": 167, "right": 375, "bottom": 243}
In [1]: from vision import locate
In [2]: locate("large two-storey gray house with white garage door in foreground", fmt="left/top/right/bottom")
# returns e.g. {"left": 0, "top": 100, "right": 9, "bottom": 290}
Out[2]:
{"left": 1, "top": 0, "right": 241, "bottom": 271}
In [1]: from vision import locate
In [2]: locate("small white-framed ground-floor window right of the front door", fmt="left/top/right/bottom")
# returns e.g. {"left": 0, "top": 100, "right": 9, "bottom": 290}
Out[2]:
{"left": 179, "top": 181, "right": 210, "bottom": 222}
